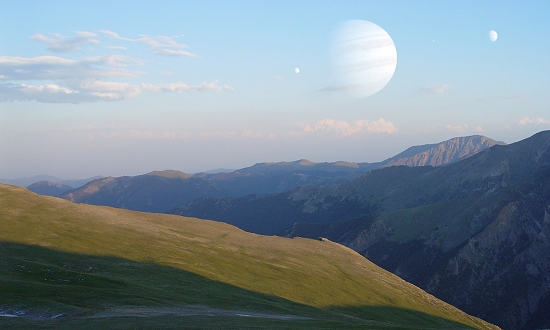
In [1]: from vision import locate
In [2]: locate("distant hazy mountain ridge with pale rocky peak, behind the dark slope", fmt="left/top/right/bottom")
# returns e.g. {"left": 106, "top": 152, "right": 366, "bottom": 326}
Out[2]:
{"left": 59, "top": 135, "right": 502, "bottom": 212}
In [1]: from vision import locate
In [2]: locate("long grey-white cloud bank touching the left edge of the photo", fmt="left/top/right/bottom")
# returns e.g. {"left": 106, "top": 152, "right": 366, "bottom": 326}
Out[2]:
{"left": 0, "top": 55, "right": 233, "bottom": 103}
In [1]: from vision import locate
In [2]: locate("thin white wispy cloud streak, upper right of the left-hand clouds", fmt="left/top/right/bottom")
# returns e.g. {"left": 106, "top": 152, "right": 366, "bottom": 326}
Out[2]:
{"left": 99, "top": 30, "right": 199, "bottom": 57}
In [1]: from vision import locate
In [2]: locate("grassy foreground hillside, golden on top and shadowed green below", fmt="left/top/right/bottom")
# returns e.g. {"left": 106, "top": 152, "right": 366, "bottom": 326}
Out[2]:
{"left": 0, "top": 185, "right": 496, "bottom": 329}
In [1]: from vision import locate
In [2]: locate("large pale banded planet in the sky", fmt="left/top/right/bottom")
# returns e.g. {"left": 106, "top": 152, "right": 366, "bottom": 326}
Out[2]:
{"left": 332, "top": 20, "right": 397, "bottom": 97}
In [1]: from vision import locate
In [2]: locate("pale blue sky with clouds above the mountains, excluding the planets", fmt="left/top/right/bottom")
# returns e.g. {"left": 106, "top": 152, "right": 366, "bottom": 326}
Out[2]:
{"left": 0, "top": 0, "right": 550, "bottom": 179}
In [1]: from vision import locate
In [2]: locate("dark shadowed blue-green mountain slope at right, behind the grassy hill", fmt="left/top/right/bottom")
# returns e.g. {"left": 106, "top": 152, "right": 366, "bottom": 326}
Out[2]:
{"left": 173, "top": 131, "right": 550, "bottom": 329}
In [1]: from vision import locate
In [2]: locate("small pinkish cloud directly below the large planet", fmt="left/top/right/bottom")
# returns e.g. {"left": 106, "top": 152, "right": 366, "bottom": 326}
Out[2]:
{"left": 296, "top": 118, "right": 397, "bottom": 136}
